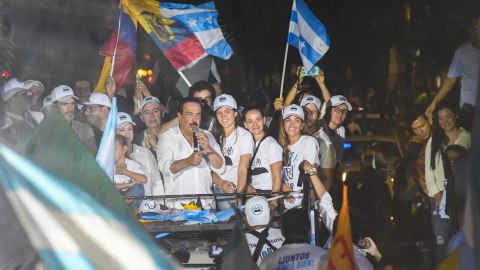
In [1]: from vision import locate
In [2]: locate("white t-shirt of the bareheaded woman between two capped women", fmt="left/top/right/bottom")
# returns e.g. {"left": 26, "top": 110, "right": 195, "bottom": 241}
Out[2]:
{"left": 252, "top": 137, "right": 283, "bottom": 190}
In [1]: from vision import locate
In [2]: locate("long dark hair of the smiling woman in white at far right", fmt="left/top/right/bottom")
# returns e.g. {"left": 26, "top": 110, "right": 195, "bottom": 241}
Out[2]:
{"left": 430, "top": 101, "right": 457, "bottom": 170}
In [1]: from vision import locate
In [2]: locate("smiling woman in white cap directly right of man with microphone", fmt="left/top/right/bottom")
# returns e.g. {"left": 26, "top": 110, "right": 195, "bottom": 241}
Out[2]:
{"left": 212, "top": 94, "right": 254, "bottom": 210}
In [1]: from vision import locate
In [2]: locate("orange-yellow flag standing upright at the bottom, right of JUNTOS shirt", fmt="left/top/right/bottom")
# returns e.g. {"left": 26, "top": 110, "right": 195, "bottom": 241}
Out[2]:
{"left": 328, "top": 186, "right": 355, "bottom": 270}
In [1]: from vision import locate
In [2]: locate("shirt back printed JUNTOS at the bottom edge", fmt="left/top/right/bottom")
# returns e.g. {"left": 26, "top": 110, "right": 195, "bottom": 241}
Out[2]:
{"left": 260, "top": 243, "right": 328, "bottom": 270}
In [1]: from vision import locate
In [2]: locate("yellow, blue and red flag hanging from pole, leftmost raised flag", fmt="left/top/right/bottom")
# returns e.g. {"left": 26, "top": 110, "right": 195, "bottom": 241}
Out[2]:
{"left": 94, "top": 0, "right": 137, "bottom": 94}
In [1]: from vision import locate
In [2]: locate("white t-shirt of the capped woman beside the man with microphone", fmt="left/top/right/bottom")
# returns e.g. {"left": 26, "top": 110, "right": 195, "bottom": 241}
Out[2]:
{"left": 220, "top": 127, "right": 255, "bottom": 185}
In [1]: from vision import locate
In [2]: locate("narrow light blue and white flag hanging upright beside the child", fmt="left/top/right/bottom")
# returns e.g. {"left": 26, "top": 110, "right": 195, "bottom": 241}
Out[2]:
{"left": 96, "top": 98, "right": 117, "bottom": 182}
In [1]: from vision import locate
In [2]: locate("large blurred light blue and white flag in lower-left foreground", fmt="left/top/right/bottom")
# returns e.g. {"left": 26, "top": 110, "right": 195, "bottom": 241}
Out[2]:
{"left": 0, "top": 145, "right": 176, "bottom": 269}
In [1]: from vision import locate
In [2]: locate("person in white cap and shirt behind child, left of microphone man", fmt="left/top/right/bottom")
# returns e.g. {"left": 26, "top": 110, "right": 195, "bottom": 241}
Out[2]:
{"left": 117, "top": 112, "right": 165, "bottom": 196}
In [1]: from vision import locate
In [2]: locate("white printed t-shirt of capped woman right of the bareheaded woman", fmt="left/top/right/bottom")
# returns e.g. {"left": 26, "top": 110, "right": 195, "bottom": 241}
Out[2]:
{"left": 282, "top": 135, "right": 320, "bottom": 209}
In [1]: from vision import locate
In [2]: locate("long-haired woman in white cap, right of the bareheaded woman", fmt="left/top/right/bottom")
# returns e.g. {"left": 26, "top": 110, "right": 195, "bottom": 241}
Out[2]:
{"left": 278, "top": 105, "right": 320, "bottom": 209}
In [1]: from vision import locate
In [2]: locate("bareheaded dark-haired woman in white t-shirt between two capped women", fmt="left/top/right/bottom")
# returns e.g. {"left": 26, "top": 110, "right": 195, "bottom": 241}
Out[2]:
{"left": 243, "top": 105, "right": 283, "bottom": 210}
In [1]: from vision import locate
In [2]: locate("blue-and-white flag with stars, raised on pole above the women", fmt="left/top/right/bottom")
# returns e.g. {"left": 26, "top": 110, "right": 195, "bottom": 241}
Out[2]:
{"left": 287, "top": 0, "right": 330, "bottom": 75}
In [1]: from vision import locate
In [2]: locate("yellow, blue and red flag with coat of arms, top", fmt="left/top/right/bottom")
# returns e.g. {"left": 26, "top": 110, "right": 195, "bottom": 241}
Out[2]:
{"left": 124, "top": 0, "right": 207, "bottom": 71}
